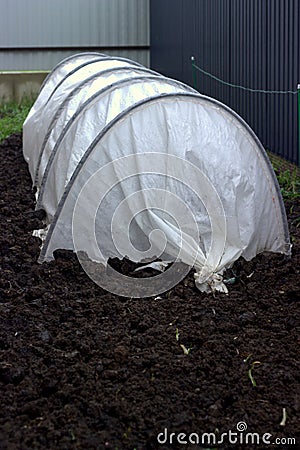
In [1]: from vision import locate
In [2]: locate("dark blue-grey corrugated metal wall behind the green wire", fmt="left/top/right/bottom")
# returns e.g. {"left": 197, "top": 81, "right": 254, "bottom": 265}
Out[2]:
{"left": 150, "top": 0, "right": 300, "bottom": 164}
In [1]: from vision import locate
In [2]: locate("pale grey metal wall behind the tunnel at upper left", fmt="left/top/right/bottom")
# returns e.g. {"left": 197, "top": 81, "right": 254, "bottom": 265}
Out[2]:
{"left": 0, "top": 0, "right": 150, "bottom": 70}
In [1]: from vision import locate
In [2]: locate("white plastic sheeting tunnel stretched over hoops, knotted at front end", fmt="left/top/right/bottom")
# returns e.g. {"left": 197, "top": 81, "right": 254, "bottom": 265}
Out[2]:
{"left": 23, "top": 54, "right": 290, "bottom": 296}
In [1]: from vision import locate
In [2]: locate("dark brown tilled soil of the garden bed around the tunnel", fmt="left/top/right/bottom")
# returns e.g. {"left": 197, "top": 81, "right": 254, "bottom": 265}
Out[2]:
{"left": 0, "top": 135, "right": 300, "bottom": 450}
